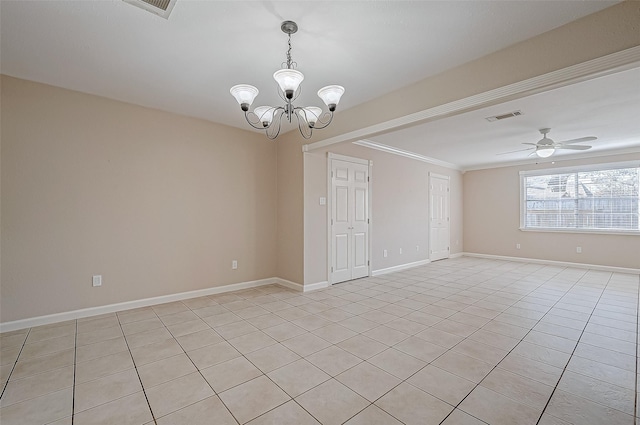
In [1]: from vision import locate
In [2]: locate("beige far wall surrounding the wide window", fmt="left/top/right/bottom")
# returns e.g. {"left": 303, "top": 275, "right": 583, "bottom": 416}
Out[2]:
{"left": 464, "top": 153, "right": 640, "bottom": 269}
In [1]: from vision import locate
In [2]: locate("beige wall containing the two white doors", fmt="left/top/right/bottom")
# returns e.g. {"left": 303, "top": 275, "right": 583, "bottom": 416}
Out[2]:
{"left": 304, "top": 143, "right": 463, "bottom": 285}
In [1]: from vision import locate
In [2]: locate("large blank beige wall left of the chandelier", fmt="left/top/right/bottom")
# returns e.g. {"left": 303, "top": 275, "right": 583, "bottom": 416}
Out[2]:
{"left": 0, "top": 76, "right": 277, "bottom": 322}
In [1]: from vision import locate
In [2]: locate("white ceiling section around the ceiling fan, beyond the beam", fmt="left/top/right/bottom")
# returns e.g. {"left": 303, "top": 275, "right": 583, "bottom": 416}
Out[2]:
{"left": 369, "top": 68, "right": 640, "bottom": 170}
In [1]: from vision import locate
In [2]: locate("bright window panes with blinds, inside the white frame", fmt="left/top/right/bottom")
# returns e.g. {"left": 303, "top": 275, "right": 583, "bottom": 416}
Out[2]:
{"left": 520, "top": 163, "right": 640, "bottom": 233}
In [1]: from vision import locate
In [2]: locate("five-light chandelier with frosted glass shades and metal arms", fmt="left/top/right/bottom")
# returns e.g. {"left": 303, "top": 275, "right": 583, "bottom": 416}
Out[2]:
{"left": 230, "top": 21, "right": 344, "bottom": 139}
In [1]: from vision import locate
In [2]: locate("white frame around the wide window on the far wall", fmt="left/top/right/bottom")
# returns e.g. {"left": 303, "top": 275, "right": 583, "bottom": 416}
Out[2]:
{"left": 519, "top": 160, "right": 640, "bottom": 236}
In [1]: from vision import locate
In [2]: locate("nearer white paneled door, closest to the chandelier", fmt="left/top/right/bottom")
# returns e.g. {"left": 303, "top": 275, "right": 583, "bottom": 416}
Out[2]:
{"left": 331, "top": 159, "right": 369, "bottom": 283}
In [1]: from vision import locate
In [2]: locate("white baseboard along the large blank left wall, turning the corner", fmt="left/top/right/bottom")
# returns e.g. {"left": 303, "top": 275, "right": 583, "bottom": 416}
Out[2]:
{"left": 0, "top": 277, "right": 302, "bottom": 333}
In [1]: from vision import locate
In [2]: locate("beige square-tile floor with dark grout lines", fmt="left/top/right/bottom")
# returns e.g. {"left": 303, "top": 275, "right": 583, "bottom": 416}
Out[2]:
{"left": 0, "top": 257, "right": 639, "bottom": 425}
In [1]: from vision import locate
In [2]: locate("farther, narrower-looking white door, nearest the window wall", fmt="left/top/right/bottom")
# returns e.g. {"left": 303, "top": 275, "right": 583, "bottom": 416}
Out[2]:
{"left": 429, "top": 173, "right": 450, "bottom": 261}
